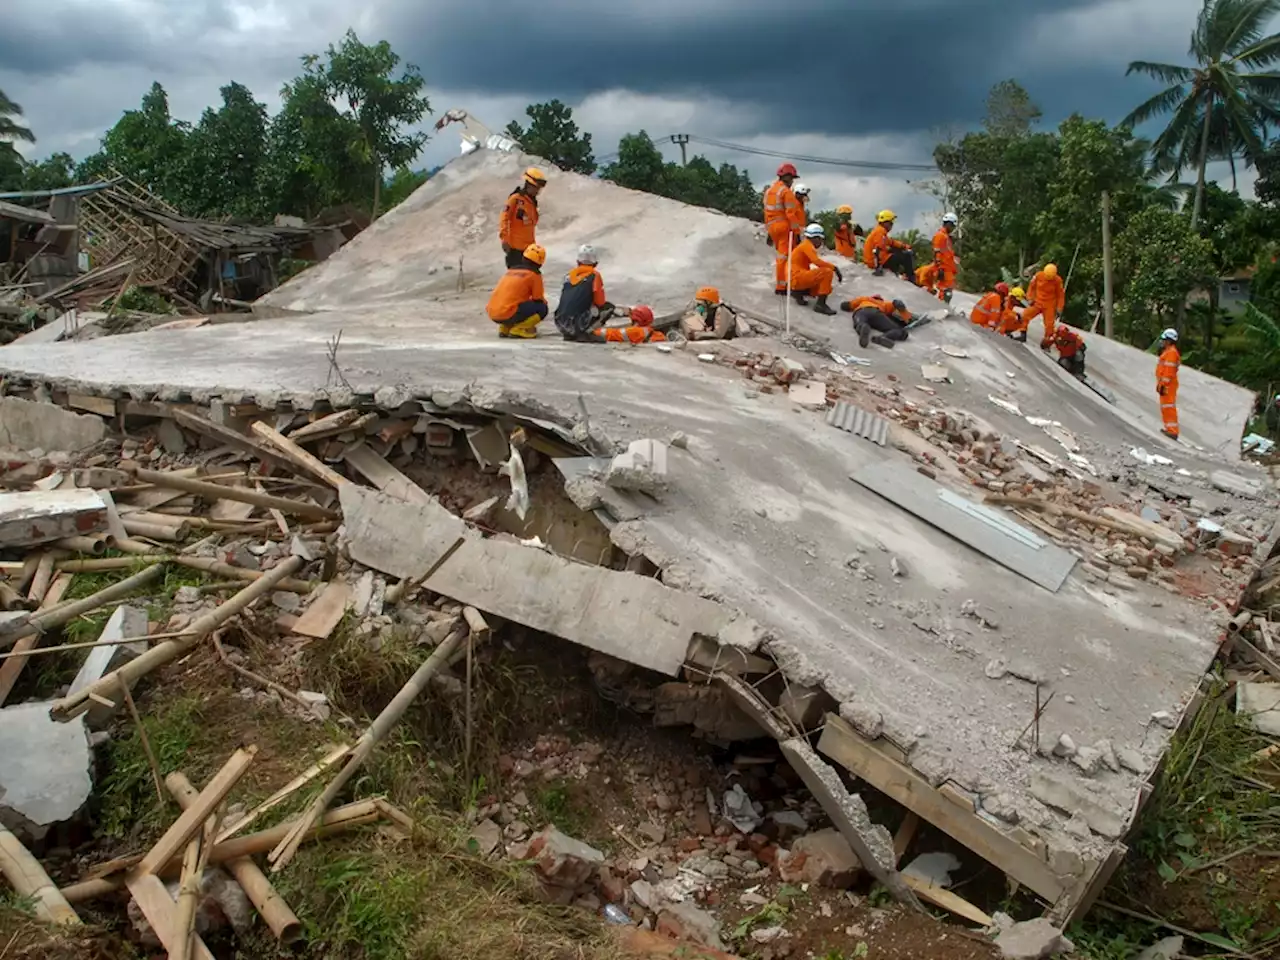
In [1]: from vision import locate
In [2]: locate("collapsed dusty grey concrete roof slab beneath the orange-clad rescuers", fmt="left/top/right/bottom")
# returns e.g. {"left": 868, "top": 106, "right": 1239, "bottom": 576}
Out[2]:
{"left": 0, "top": 152, "right": 1274, "bottom": 896}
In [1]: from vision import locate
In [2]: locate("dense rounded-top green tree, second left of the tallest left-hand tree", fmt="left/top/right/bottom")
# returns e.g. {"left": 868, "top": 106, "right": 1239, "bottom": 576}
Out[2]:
{"left": 180, "top": 83, "right": 268, "bottom": 218}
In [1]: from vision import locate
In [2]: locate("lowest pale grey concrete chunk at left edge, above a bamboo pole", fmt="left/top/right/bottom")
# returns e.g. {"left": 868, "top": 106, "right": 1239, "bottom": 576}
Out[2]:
{"left": 0, "top": 703, "right": 93, "bottom": 844}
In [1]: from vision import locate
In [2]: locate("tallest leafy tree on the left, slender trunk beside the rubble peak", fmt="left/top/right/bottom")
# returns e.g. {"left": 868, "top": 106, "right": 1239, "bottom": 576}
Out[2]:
{"left": 311, "top": 29, "right": 431, "bottom": 216}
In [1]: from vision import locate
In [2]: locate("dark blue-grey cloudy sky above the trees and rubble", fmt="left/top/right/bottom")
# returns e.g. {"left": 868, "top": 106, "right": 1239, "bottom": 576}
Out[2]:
{"left": 0, "top": 0, "right": 1259, "bottom": 225}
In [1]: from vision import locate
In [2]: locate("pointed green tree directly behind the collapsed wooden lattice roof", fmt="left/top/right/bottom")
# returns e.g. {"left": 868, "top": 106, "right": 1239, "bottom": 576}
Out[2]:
{"left": 76, "top": 83, "right": 191, "bottom": 200}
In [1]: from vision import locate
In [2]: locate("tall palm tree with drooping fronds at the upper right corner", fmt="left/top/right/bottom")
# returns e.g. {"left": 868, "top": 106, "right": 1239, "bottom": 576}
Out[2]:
{"left": 1124, "top": 0, "right": 1280, "bottom": 228}
